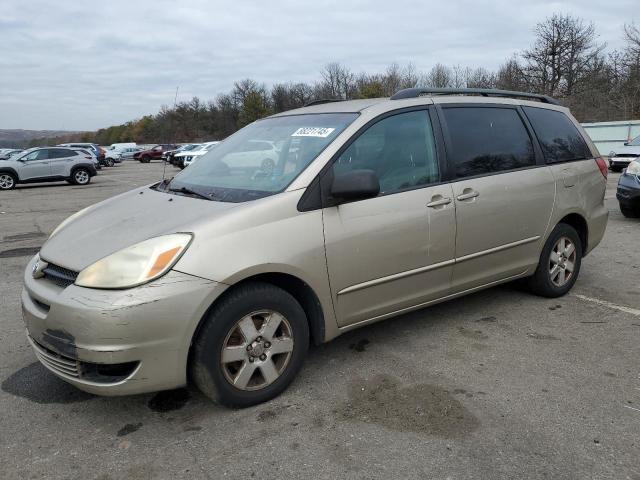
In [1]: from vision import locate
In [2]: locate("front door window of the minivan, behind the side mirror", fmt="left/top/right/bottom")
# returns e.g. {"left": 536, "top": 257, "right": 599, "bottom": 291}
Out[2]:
{"left": 333, "top": 110, "right": 440, "bottom": 194}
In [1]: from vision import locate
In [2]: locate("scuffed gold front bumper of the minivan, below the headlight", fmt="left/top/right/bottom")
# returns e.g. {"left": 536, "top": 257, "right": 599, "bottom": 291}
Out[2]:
{"left": 22, "top": 258, "right": 226, "bottom": 395}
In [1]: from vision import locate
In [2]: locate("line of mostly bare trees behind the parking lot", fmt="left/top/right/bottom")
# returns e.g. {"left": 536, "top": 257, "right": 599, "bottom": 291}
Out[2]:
{"left": 30, "top": 14, "right": 640, "bottom": 146}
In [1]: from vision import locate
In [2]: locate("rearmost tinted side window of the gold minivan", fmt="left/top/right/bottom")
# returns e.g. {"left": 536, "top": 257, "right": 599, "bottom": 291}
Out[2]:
{"left": 524, "top": 107, "right": 592, "bottom": 163}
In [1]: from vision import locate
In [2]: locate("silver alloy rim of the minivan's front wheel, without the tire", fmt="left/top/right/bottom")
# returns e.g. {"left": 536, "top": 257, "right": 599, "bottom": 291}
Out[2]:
{"left": 220, "top": 310, "right": 294, "bottom": 390}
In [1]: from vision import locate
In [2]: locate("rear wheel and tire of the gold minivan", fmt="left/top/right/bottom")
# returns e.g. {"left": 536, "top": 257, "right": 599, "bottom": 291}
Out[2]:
{"left": 527, "top": 223, "right": 583, "bottom": 298}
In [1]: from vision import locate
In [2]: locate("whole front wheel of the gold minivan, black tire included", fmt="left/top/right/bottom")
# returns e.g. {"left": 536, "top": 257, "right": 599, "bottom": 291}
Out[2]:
{"left": 191, "top": 282, "right": 309, "bottom": 407}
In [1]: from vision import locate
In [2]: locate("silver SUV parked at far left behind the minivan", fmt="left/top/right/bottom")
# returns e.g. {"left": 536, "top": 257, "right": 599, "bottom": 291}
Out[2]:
{"left": 0, "top": 147, "right": 97, "bottom": 190}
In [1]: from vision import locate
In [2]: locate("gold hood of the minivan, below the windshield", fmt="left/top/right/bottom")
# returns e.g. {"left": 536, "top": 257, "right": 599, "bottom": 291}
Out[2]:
{"left": 40, "top": 187, "right": 238, "bottom": 272}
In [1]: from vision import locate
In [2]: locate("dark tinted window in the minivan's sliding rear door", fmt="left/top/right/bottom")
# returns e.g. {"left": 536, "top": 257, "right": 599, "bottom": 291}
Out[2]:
{"left": 443, "top": 107, "right": 536, "bottom": 178}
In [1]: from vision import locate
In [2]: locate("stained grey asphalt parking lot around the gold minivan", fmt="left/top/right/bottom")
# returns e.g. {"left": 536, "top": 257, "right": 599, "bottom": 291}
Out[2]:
{"left": 0, "top": 162, "right": 640, "bottom": 480}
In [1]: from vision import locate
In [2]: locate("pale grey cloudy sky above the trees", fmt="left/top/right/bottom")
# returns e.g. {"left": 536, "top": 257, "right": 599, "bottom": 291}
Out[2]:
{"left": 0, "top": 0, "right": 640, "bottom": 130}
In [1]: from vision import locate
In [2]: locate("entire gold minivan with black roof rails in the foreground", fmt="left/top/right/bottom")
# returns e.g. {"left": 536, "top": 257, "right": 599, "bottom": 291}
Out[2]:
{"left": 22, "top": 88, "right": 608, "bottom": 406}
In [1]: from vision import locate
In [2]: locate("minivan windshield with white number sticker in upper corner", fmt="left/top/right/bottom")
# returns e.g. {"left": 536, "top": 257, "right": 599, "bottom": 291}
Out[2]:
{"left": 159, "top": 113, "right": 358, "bottom": 202}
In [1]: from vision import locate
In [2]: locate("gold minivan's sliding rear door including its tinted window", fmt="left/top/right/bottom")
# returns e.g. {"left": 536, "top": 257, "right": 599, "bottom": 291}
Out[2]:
{"left": 439, "top": 104, "right": 555, "bottom": 292}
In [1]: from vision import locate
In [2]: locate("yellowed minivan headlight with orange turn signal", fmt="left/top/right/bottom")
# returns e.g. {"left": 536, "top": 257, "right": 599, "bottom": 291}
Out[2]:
{"left": 75, "top": 233, "right": 193, "bottom": 288}
